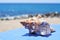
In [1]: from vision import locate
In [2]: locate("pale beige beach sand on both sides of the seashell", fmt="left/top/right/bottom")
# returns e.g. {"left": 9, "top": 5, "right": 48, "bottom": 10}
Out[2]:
{"left": 0, "top": 17, "right": 60, "bottom": 32}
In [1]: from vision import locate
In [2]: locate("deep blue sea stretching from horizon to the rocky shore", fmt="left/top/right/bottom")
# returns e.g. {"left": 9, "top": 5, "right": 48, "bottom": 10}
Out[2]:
{"left": 0, "top": 3, "right": 60, "bottom": 17}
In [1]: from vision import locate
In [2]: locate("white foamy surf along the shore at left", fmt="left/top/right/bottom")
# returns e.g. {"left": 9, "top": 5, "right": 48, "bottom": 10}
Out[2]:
{"left": 0, "top": 14, "right": 28, "bottom": 20}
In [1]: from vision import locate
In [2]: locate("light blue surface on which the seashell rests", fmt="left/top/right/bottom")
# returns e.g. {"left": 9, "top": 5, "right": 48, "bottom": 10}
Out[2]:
{"left": 0, "top": 24, "right": 60, "bottom": 40}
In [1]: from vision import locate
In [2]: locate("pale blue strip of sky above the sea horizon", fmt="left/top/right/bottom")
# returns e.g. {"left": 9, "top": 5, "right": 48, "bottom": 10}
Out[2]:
{"left": 0, "top": 0, "right": 60, "bottom": 3}
